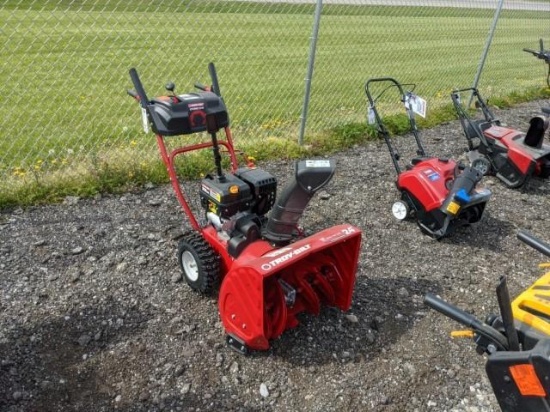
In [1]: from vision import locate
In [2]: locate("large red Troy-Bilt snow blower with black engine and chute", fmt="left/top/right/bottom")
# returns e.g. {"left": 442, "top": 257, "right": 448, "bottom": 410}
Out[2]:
{"left": 128, "top": 63, "right": 361, "bottom": 353}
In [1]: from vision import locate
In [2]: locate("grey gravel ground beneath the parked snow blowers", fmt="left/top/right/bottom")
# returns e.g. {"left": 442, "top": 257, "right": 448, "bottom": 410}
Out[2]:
{"left": 0, "top": 101, "right": 550, "bottom": 412}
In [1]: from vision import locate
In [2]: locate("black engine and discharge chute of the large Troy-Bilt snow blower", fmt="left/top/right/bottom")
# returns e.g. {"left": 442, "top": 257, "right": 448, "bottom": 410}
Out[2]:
{"left": 200, "top": 159, "right": 335, "bottom": 257}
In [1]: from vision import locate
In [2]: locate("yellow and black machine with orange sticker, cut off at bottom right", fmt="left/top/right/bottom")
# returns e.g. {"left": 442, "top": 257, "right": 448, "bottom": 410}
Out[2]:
{"left": 424, "top": 232, "right": 550, "bottom": 412}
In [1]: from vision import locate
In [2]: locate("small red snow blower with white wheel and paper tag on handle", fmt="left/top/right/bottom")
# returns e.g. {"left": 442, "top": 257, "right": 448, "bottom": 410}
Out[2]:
{"left": 365, "top": 77, "right": 491, "bottom": 239}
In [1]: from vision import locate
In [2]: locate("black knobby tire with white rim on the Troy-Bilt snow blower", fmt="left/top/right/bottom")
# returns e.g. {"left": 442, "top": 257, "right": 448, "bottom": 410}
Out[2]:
{"left": 178, "top": 232, "right": 220, "bottom": 294}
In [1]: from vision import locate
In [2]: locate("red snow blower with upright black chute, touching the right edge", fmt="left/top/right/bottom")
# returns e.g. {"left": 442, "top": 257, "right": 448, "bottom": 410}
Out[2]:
{"left": 451, "top": 88, "right": 550, "bottom": 189}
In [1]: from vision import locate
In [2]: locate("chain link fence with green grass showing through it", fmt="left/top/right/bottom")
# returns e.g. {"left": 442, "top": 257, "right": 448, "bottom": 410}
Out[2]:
{"left": 0, "top": 0, "right": 550, "bottom": 206}
